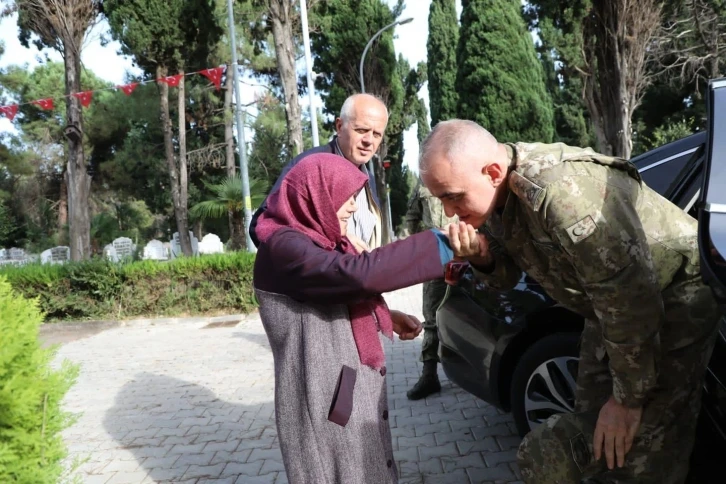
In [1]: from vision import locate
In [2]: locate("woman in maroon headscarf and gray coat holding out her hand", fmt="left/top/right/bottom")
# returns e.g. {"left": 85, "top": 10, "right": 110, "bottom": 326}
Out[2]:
{"left": 254, "top": 154, "right": 451, "bottom": 484}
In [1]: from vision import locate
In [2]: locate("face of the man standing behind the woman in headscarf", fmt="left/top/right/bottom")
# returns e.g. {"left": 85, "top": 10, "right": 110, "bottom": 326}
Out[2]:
{"left": 335, "top": 98, "right": 388, "bottom": 165}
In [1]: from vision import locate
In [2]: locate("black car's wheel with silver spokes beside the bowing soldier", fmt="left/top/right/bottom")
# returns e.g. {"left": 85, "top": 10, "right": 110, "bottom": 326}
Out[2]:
{"left": 510, "top": 333, "right": 580, "bottom": 436}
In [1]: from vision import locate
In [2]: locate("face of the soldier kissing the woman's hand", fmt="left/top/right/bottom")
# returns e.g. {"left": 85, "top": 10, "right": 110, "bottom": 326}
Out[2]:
{"left": 422, "top": 149, "right": 496, "bottom": 228}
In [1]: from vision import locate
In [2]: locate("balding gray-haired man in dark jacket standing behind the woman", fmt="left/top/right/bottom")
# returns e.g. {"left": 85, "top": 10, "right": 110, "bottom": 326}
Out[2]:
{"left": 250, "top": 94, "right": 388, "bottom": 250}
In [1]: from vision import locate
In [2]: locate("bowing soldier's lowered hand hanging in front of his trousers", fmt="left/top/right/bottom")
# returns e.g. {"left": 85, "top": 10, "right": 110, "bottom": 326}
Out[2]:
{"left": 592, "top": 396, "right": 643, "bottom": 469}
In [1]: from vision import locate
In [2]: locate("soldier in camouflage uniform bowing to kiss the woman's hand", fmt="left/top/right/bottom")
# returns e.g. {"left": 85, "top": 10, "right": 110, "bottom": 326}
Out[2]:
{"left": 421, "top": 120, "right": 720, "bottom": 484}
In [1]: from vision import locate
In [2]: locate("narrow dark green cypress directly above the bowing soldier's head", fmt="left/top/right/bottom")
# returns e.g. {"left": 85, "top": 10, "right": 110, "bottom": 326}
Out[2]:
{"left": 426, "top": 0, "right": 459, "bottom": 126}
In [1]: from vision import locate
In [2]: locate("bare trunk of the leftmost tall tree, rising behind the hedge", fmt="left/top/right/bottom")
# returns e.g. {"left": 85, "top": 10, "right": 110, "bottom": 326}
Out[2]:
{"left": 64, "top": 45, "right": 91, "bottom": 261}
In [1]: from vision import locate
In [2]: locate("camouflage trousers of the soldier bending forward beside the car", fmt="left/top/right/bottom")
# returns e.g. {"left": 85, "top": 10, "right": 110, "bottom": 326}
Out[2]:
{"left": 517, "top": 278, "right": 720, "bottom": 484}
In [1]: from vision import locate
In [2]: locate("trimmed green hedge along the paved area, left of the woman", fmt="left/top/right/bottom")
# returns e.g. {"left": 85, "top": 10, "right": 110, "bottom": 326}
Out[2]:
{"left": 0, "top": 252, "right": 256, "bottom": 322}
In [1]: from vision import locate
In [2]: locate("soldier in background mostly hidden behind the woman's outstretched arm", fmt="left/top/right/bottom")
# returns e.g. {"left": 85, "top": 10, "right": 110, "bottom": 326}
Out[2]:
{"left": 403, "top": 180, "right": 457, "bottom": 400}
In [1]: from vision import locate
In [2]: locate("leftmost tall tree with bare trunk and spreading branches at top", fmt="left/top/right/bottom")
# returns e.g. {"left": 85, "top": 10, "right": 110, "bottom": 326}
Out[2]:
{"left": 5, "top": 0, "right": 100, "bottom": 260}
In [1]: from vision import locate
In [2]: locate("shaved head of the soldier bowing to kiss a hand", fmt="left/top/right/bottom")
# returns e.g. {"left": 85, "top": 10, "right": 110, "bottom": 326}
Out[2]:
{"left": 419, "top": 119, "right": 510, "bottom": 227}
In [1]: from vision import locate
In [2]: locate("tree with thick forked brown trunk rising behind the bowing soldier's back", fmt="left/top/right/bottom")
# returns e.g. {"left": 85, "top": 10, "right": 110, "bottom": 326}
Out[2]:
{"left": 525, "top": 0, "right": 663, "bottom": 158}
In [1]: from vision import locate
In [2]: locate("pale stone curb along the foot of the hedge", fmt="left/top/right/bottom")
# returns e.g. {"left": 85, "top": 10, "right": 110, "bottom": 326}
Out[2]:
{"left": 40, "top": 311, "right": 258, "bottom": 336}
